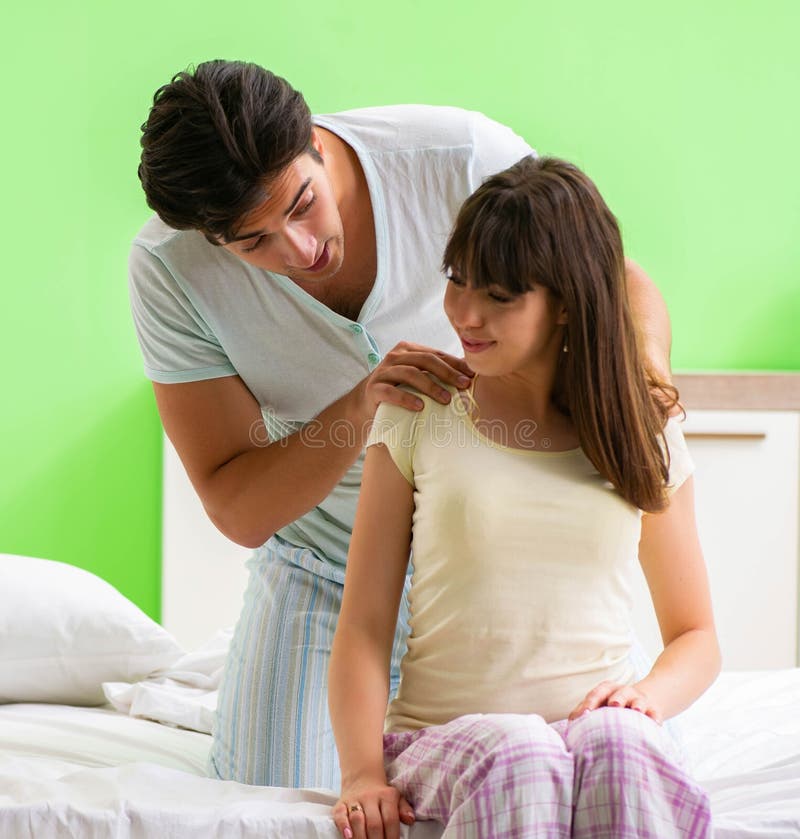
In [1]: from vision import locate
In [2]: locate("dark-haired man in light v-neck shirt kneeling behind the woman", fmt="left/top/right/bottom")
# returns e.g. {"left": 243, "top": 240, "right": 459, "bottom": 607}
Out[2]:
{"left": 130, "top": 61, "right": 669, "bottom": 789}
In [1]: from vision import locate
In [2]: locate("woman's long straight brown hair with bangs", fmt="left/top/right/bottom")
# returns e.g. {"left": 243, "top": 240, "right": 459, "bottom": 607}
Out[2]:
{"left": 444, "top": 157, "right": 678, "bottom": 512}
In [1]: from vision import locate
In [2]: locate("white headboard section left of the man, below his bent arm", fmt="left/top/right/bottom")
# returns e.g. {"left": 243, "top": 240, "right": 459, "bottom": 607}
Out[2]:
{"left": 161, "top": 436, "right": 253, "bottom": 650}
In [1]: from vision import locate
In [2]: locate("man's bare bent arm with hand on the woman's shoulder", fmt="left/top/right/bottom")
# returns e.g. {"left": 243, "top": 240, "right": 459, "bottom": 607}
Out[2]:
{"left": 153, "top": 344, "right": 468, "bottom": 548}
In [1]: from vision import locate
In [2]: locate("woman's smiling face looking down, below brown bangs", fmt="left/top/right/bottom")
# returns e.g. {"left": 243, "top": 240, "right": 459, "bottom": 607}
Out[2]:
{"left": 444, "top": 273, "right": 566, "bottom": 376}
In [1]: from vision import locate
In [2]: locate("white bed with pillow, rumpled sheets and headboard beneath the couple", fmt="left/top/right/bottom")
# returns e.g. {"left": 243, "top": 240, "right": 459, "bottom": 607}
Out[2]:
{"left": 0, "top": 426, "right": 800, "bottom": 839}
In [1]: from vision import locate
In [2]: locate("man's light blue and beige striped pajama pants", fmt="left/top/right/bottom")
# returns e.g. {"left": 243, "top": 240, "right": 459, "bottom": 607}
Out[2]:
{"left": 208, "top": 536, "right": 408, "bottom": 790}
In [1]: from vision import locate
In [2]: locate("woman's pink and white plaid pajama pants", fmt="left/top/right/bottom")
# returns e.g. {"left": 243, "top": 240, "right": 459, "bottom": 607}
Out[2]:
{"left": 384, "top": 708, "right": 712, "bottom": 839}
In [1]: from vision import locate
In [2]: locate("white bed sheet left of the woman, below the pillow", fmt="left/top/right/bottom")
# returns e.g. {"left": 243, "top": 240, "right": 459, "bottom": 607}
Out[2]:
{"left": 0, "top": 704, "right": 439, "bottom": 839}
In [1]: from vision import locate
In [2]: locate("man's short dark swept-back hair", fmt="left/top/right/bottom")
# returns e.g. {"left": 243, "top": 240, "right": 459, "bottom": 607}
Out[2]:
{"left": 139, "top": 61, "right": 320, "bottom": 244}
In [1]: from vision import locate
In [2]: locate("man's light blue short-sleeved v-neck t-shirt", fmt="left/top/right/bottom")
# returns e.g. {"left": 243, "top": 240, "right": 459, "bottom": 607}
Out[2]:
{"left": 129, "top": 105, "right": 532, "bottom": 567}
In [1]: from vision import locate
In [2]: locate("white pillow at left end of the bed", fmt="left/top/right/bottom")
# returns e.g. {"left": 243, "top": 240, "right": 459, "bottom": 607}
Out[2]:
{"left": 0, "top": 554, "right": 183, "bottom": 705}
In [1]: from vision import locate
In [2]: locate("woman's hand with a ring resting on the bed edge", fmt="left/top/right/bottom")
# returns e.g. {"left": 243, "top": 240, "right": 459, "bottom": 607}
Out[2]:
{"left": 333, "top": 781, "right": 414, "bottom": 839}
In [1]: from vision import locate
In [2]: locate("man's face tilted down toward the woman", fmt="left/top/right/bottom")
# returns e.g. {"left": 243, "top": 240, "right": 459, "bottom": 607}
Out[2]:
{"left": 222, "top": 146, "right": 344, "bottom": 282}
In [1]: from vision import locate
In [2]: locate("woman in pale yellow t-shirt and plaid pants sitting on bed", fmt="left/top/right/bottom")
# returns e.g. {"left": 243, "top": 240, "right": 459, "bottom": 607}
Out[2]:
{"left": 329, "top": 158, "right": 720, "bottom": 839}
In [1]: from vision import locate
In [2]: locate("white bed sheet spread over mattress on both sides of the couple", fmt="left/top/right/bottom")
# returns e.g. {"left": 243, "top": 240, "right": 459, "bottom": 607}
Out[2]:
{"left": 0, "top": 670, "right": 800, "bottom": 839}
